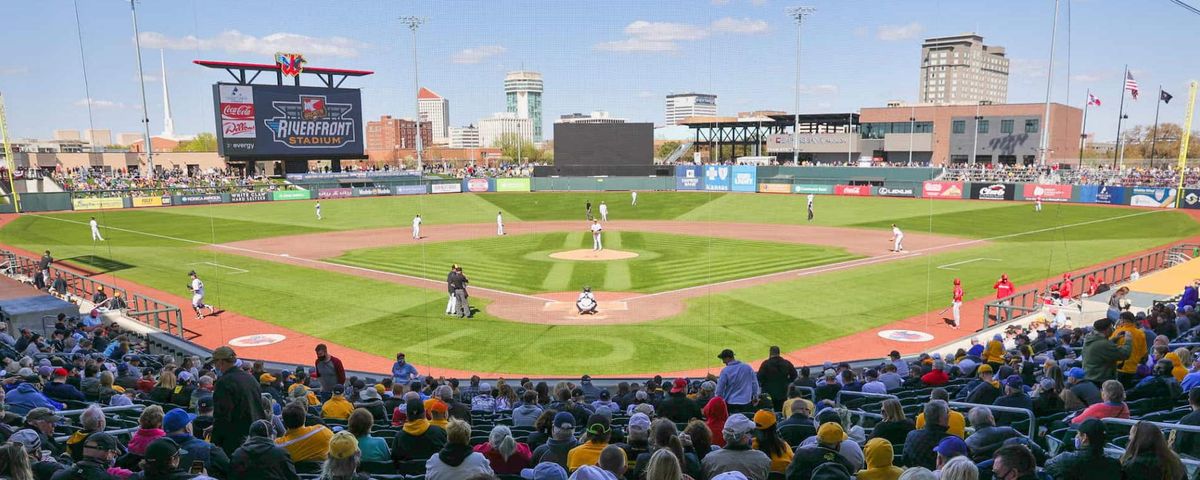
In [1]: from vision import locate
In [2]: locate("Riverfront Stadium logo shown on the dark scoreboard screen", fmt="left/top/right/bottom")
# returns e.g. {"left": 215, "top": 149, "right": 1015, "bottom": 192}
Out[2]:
{"left": 263, "top": 95, "right": 359, "bottom": 149}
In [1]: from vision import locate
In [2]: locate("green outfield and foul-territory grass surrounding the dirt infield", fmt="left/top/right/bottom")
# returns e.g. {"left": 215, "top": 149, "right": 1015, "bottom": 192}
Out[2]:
{"left": 0, "top": 192, "right": 1200, "bottom": 376}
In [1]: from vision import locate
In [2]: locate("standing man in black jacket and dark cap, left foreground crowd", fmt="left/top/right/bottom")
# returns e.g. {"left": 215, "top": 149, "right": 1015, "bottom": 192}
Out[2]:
{"left": 211, "top": 346, "right": 264, "bottom": 454}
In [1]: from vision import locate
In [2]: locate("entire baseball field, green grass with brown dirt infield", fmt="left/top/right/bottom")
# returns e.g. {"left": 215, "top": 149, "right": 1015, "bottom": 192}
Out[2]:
{"left": 0, "top": 192, "right": 1200, "bottom": 376}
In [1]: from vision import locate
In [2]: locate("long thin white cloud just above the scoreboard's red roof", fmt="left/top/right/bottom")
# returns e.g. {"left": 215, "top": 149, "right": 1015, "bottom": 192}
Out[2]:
{"left": 140, "top": 30, "right": 368, "bottom": 58}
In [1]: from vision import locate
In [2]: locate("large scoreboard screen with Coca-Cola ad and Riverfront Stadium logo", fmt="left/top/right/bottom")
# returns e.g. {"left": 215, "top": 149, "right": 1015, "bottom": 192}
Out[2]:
{"left": 212, "top": 84, "right": 362, "bottom": 157}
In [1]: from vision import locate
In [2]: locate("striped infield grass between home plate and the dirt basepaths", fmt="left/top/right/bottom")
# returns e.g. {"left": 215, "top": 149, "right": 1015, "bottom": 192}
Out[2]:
{"left": 332, "top": 232, "right": 859, "bottom": 293}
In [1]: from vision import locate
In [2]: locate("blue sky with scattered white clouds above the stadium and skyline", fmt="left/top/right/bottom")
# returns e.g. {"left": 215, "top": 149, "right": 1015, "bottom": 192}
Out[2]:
{"left": 0, "top": 0, "right": 1200, "bottom": 139}
